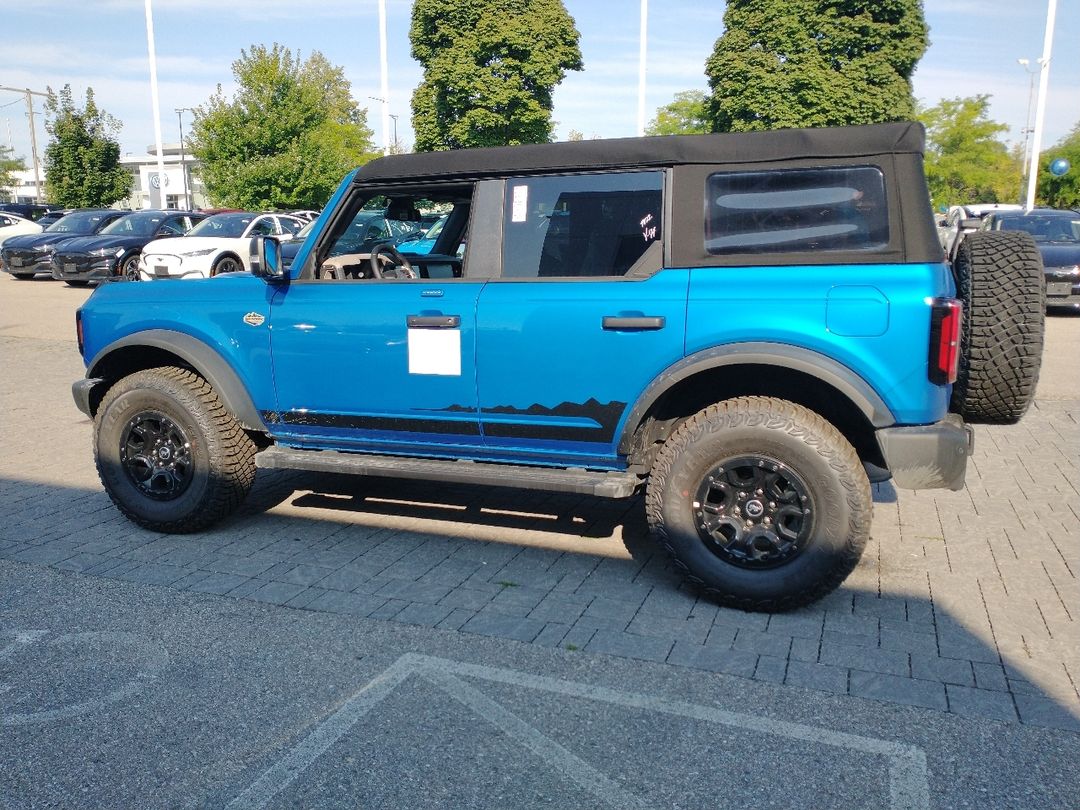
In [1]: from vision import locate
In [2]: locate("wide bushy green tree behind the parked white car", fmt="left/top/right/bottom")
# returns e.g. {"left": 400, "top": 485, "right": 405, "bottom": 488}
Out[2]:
{"left": 189, "top": 43, "right": 376, "bottom": 211}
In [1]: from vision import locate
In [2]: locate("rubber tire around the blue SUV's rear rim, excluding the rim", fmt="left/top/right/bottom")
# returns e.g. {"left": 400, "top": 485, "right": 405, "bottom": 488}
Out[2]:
{"left": 645, "top": 396, "right": 873, "bottom": 611}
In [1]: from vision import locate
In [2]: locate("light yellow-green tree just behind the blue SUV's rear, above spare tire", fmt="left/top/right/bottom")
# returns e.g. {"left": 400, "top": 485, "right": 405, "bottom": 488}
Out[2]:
{"left": 918, "top": 95, "right": 1023, "bottom": 207}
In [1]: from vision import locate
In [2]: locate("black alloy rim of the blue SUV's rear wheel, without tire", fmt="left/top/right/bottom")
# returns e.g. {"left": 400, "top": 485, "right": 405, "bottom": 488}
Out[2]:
{"left": 693, "top": 455, "right": 814, "bottom": 568}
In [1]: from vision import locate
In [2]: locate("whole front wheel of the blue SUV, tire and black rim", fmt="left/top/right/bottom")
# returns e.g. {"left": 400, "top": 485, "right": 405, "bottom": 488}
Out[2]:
{"left": 94, "top": 367, "right": 255, "bottom": 534}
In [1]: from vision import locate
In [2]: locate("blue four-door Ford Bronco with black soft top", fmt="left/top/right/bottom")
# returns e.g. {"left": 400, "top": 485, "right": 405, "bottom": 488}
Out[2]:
{"left": 73, "top": 123, "right": 1044, "bottom": 610}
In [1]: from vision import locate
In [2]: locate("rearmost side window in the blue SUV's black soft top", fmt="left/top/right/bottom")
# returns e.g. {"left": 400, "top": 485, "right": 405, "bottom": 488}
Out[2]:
{"left": 705, "top": 166, "right": 889, "bottom": 255}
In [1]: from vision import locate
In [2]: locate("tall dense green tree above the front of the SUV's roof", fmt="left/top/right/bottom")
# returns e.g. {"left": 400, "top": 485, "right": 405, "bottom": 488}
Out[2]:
{"left": 409, "top": 0, "right": 582, "bottom": 151}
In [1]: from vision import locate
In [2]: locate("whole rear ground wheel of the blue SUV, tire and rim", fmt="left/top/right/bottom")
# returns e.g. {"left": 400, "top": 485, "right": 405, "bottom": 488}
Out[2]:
{"left": 646, "top": 396, "right": 873, "bottom": 611}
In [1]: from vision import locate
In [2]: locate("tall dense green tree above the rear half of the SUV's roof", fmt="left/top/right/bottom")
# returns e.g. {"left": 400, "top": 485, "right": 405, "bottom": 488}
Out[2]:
{"left": 705, "top": 0, "right": 928, "bottom": 132}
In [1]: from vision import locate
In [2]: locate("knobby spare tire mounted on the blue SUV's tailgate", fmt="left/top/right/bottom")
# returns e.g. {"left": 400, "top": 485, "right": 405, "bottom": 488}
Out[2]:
{"left": 951, "top": 231, "right": 1047, "bottom": 424}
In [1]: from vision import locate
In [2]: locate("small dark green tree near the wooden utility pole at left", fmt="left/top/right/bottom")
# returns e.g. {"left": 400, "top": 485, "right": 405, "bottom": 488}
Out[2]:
{"left": 45, "top": 84, "right": 135, "bottom": 208}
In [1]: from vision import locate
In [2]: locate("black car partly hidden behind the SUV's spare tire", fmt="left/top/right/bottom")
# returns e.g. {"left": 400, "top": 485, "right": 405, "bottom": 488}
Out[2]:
{"left": 983, "top": 208, "right": 1080, "bottom": 309}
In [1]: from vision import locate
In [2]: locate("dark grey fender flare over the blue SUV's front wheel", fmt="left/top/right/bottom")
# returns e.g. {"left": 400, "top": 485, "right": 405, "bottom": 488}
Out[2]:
{"left": 82, "top": 329, "right": 267, "bottom": 431}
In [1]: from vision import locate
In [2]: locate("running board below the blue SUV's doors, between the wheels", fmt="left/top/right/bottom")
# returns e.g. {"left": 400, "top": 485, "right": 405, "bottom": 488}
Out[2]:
{"left": 255, "top": 446, "right": 642, "bottom": 498}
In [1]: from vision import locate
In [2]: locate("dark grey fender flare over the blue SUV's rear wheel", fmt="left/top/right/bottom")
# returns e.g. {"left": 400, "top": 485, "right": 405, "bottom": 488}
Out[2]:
{"left": 619, "top": 341, "right": 896, "bottom": 455}
